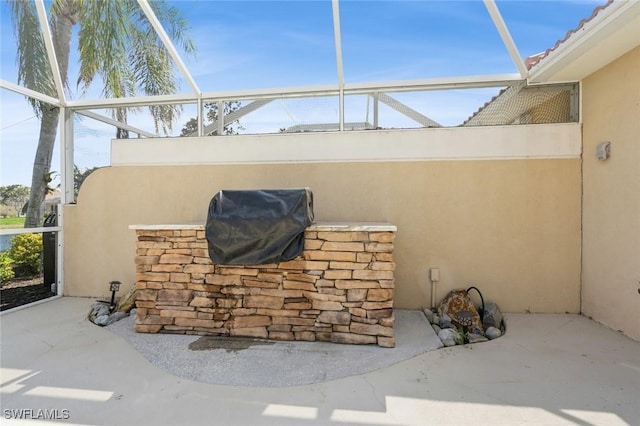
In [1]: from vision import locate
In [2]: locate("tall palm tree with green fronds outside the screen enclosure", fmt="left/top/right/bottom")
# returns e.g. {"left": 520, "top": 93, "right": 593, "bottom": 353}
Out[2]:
{"left": 11, "top": 0, "right": 195, "bottom": 227}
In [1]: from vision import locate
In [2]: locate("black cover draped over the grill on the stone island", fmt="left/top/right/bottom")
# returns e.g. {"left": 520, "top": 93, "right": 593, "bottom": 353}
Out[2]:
{"left": 205, "top": 188, "right": 313, "bottom": 265}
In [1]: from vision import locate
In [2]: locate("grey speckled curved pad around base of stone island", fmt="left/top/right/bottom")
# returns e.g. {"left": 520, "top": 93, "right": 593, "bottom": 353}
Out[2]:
{"left": 106, "top": 309, "right": 442, "bottom": 387}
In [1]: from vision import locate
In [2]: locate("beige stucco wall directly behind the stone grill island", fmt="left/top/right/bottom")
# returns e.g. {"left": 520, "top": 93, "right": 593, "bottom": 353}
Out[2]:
{"left": 64, "top": 153, "right": 580, "bottom": 312}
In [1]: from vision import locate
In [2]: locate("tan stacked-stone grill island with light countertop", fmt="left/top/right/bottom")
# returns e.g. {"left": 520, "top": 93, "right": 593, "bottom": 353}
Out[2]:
{"left": 129, "top": 223, "right": 396, "bottom": 347}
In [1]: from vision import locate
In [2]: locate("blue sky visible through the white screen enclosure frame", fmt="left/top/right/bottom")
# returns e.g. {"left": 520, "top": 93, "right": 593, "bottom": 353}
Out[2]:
{"left": 0, "top": 0, "right": 604, "bottom": 185}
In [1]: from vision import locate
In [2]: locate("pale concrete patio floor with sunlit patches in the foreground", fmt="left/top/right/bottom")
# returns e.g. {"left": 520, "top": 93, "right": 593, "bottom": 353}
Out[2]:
{"left": 0, "top": 298, "right": 640, "bottom": 426}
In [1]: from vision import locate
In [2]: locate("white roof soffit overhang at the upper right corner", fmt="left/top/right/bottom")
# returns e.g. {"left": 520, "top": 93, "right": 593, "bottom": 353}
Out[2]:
{"left": 529, "top": 0, "right": 640, "bottom": 83}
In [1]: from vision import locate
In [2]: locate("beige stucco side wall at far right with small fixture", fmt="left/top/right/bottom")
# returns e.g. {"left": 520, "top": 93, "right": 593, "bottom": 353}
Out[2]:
{"left": 582, "top": 47, "right": 640, "bottom": 340}
